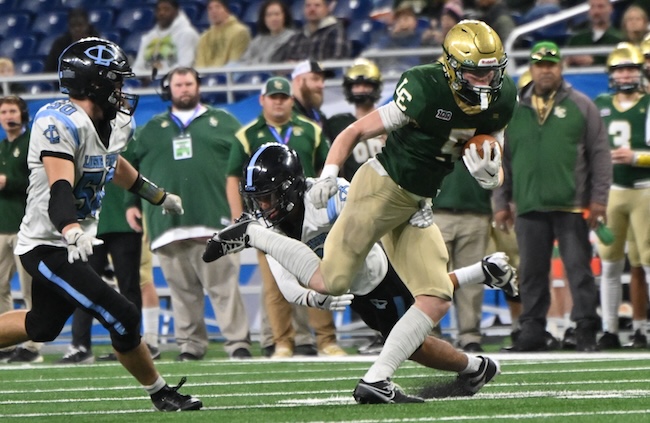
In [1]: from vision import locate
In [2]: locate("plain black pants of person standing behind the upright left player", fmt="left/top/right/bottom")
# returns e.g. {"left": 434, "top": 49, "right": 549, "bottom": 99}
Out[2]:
{"left": 72, "top": 232, "right": 142, "bottom": 351}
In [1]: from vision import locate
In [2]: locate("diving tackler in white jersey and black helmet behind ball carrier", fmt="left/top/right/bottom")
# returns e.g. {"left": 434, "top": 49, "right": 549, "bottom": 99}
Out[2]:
{"left": 204, "top": 143, "right": 518, "bottom": 398}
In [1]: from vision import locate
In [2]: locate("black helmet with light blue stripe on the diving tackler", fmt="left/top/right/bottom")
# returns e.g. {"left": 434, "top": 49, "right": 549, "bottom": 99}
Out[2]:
{"left": 240, "top": 143, "right": 306, "bottom": 227}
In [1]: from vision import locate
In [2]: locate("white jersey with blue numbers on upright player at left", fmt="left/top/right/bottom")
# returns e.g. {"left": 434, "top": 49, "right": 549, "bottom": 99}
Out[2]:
{"left": 15, "top": 100, "right": 135, "bottom": 255}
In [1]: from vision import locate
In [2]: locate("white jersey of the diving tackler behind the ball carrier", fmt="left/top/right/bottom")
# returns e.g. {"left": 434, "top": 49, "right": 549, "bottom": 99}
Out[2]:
{"left": 266, "top": 178, "right": 388, "bottom": 295}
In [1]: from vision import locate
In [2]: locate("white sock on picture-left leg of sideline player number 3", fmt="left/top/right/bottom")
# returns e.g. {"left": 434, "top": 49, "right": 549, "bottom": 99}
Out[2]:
{"left": 600, "top": 260, "right": 625, "bottom": 333}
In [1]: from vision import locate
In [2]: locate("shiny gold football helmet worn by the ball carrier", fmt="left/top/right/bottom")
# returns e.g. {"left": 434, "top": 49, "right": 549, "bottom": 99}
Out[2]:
{"left": 442, "top": 20, "right": 508, "bottom": 110}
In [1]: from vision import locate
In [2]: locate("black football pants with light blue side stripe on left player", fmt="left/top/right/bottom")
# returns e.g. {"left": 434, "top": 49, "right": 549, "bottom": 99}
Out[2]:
{"left": 20, "top": 245, "right": 140, "bottom": 352}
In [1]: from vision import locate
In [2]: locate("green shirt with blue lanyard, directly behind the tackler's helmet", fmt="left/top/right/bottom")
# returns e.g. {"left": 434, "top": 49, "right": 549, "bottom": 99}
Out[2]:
{"left": 227, "top": 112, "right": 329, "bottom": 177}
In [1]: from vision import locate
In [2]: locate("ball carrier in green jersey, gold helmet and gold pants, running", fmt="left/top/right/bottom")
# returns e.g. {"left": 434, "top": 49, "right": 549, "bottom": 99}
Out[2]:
{"left": 206, "top": 20, "right": 517, "bottom": 403}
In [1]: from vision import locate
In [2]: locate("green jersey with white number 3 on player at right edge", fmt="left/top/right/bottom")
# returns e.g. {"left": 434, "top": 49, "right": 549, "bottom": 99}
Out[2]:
{"left": 594, "top": 94, "right": 650, "bottom": 188}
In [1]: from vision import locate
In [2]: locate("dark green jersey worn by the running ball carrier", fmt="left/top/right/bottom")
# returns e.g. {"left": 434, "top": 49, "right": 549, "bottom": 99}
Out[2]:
{"left": 377, "top": 63, "right": 517, "bottom": 197}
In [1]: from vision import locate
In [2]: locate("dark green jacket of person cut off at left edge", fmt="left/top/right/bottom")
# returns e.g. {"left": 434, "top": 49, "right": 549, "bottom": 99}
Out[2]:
{"left": 0, "top": 130, "right": 30, "bottom": 234}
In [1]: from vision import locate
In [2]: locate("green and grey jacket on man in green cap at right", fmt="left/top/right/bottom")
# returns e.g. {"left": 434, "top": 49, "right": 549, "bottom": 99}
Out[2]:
{"left": 493, "top": 82, "right": 612, "bottom": 215}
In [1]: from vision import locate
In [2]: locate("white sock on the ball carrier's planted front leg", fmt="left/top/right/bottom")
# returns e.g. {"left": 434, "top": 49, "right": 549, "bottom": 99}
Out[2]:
{"left": 363, "top": 306, "right": 435, "bottom": 383}
